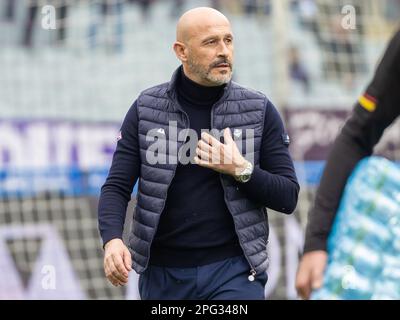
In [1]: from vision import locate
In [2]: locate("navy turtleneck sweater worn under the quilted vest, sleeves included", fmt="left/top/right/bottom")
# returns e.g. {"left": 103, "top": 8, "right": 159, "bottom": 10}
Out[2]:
{"left": 98, "top": 68, "right": 299, "bottom": 267}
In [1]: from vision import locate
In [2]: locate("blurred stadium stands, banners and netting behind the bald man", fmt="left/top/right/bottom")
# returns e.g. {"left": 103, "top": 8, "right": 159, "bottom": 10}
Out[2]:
{"left": 0, "top": 0, "right": 400, "bottom": 299}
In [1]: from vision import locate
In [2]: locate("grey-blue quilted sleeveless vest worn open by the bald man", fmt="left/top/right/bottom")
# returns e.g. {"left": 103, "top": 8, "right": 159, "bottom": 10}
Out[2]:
{"left": 128, "top": 69, "right": 269, "bottom": 275}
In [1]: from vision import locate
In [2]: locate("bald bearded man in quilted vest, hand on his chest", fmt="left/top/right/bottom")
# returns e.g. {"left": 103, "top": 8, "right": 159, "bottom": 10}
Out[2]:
{"left": 98, "top": 7, "right": 299, "bottom": 300}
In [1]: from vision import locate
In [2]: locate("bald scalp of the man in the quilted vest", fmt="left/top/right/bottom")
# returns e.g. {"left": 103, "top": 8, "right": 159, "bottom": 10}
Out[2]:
{"left": 176, "top": 7, "right": 230, "bottom": 43}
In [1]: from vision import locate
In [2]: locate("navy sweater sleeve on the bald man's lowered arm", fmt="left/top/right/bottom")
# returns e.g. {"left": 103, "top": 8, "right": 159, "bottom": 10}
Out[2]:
{"left": 98, "top": 102, "right": 141, "bottom": 246}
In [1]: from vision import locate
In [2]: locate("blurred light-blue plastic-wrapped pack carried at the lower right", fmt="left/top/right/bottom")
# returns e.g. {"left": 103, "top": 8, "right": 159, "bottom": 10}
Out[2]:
{"left": 311, "top": 156, "right": 400, "bottom": 300}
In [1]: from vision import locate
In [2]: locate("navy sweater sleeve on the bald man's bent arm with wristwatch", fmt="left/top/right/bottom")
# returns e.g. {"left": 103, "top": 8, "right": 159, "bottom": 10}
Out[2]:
{"left": 239, "top": 101, "right": 300, "bottom": 214}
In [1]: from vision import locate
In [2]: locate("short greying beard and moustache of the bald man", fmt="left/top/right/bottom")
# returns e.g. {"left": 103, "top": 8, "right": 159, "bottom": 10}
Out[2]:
{"left": 188, "top": 58, "right": 232, "bottom": 86}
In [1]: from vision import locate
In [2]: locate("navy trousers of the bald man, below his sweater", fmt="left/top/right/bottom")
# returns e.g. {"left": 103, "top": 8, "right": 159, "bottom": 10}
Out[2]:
{"left": 139, "top": 256, "right": 268, "bottom": 300}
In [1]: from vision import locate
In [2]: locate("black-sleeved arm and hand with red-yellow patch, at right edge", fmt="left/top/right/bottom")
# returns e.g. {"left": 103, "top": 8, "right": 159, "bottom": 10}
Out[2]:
{"left": 296, "top": 31, "right": 400, "bottom": 299}
